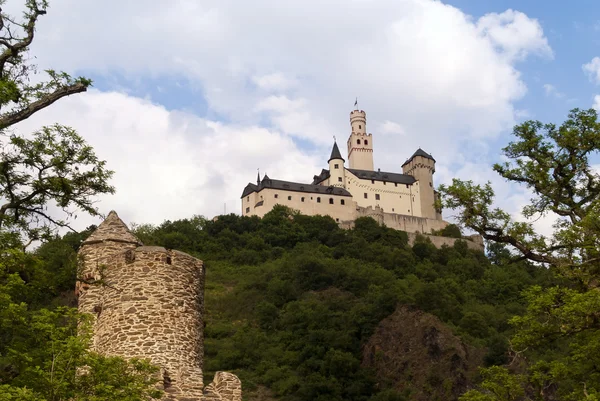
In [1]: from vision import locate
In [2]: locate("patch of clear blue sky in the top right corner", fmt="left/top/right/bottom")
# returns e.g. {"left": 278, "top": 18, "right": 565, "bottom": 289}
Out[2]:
{"left": 446, "top": 0, "right": 600, "bottom": 123}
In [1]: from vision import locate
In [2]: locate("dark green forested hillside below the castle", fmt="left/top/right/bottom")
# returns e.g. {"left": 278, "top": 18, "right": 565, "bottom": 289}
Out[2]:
{"left": 124, "top": 207, "right": 549, "bottom": 401}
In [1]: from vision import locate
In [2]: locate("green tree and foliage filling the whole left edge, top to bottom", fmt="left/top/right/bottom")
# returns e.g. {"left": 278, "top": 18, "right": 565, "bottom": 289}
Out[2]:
{"left": 0, "top": 0, "right": 160, "bottom": 401}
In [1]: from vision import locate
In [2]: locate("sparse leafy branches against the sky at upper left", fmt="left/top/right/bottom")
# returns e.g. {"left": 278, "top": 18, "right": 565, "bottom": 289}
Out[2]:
{"left": 0, "top": 0, "right": 114, "bottom": 239}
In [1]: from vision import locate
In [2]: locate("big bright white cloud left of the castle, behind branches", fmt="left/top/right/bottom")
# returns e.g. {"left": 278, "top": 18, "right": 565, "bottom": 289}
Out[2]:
{"left": 11, "top": 90, "right": 318, "bottom": 228}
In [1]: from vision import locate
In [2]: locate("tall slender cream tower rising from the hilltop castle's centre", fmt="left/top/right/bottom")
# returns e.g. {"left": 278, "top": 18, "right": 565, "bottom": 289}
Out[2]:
{"left": 348, "top": 110, "right": 374, "bottom": 171}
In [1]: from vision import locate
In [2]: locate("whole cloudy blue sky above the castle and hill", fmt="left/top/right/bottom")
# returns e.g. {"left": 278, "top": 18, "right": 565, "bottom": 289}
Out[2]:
{"left": 3, "top": 0, "right": 600, "bottom": 230}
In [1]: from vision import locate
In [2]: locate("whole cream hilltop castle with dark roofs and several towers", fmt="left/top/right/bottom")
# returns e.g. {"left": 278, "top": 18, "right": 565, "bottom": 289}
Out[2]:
{"left": 241, "top": 110, "right": 448, "bottom": 234}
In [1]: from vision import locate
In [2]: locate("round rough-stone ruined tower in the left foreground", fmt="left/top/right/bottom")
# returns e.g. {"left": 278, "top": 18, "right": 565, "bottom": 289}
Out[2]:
{"left": 76, "top": 211, "right": 242, "bottom": 401}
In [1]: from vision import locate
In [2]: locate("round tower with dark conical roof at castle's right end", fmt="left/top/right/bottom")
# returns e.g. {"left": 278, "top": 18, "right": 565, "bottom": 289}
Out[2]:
{"left": 402, "top": 148, "right": 442, "bottom": 220}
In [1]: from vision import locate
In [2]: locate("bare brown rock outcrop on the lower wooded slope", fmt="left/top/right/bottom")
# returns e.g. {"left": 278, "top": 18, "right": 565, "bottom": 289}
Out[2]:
{"left": 362, "top": 306, "right": 485, "bottom": 401}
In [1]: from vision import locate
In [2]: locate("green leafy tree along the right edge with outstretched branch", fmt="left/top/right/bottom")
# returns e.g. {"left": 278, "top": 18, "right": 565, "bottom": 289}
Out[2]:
{"left": 439, "top": 109, "right": 600, "bottom": 400}
